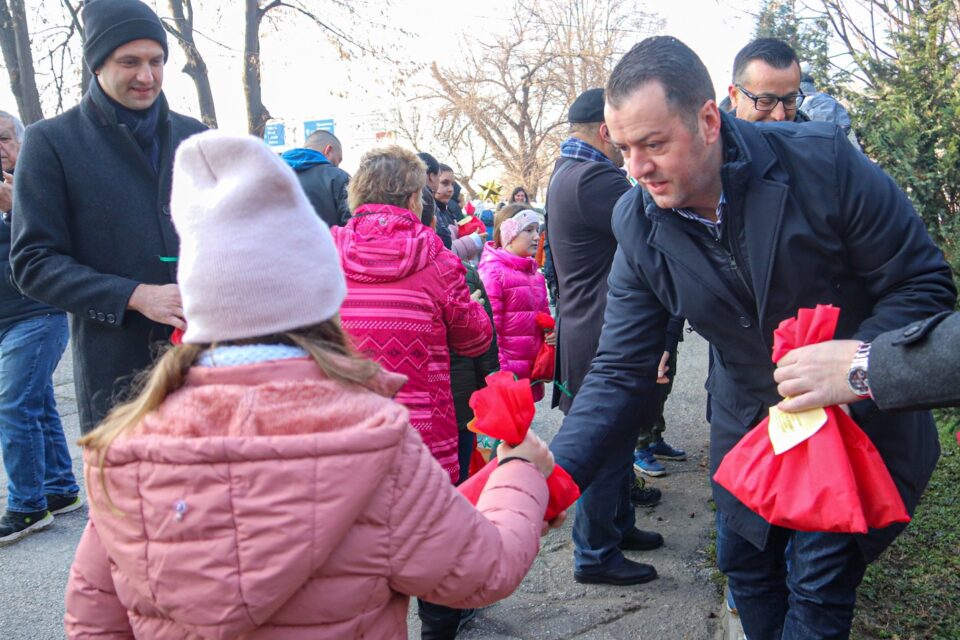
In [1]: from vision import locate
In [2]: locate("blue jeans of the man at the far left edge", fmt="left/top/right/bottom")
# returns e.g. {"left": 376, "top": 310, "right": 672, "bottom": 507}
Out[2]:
{"left": 0, "top": 313, "right": 80, "bottom": 513}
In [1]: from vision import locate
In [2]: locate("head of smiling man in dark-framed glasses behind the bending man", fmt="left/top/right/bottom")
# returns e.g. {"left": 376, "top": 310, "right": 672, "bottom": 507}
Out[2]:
{"left": 728, "top": 38, "right": 809, "bottom": 122}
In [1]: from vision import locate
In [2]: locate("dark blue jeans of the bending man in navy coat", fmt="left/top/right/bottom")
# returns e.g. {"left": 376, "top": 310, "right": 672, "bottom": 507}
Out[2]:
{"left": 717, "top": 512, "right": 867, "bottom": 640}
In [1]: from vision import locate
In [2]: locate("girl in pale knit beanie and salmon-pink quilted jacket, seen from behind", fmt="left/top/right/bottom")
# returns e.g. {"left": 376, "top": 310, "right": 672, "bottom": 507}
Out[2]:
{"left": 65, "top": 131, "right": 553, "bottom": 640}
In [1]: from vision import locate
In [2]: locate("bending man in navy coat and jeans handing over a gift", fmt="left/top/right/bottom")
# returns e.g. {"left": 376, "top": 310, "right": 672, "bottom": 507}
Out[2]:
{"left": 551, "top": 37, "right": 956, "bottom": 638}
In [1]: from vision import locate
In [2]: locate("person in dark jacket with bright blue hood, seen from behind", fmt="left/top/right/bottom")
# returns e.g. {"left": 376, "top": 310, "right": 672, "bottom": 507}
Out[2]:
{"left": 281, "top": 131, "right": 352, "bottom": 227}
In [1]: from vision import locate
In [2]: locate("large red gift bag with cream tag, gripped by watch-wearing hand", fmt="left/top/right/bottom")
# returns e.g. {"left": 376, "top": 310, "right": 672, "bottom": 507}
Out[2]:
{"left": 713, "top": 305, "right": 910, "bottom": 533}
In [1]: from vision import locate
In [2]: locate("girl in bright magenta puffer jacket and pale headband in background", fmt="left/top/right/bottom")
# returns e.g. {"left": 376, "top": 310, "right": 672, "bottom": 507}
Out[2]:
{"left": 479, "top": 204, "right": 556, "bottom": 400}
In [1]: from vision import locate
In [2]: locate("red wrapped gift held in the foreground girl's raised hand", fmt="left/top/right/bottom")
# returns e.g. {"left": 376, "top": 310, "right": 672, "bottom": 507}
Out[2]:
{"left": 457, "top": 371, "right": 580, "bottom": 522}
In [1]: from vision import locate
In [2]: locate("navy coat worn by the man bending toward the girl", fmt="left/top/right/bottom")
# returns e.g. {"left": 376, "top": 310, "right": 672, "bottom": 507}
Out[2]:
{"left": 551, "top": 114, "right": 956, "bottom": 561}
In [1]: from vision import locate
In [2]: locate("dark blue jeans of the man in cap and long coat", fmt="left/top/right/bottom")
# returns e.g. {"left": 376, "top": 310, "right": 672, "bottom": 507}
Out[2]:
{"left": 573, "top": 449, "right": 636, "bottom": 573}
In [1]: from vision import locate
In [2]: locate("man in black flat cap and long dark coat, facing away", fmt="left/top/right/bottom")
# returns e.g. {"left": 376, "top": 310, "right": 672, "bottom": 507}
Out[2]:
{"left": 547, "top": 89, "right": 664, "bottom": 585}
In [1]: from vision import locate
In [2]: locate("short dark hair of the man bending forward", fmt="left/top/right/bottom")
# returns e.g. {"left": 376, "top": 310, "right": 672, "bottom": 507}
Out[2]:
{"left": 605, "top": 36, "right": 716, "bottom": 126}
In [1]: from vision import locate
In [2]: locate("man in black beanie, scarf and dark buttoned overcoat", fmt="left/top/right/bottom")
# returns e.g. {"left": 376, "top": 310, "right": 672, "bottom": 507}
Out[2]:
{"left": 10, "top": 0, "right": 205, "bottom": 433}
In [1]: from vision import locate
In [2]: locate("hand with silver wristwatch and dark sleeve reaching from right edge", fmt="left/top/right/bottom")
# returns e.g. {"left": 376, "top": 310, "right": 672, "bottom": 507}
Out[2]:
{"left": 774, "top": 311, "right": 960, "bottom": 411}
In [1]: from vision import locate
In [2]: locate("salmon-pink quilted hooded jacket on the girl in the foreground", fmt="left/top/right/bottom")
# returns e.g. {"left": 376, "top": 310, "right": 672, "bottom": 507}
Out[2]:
{"left": 66, "top": 358, "right": 547, "bottom": 640}
